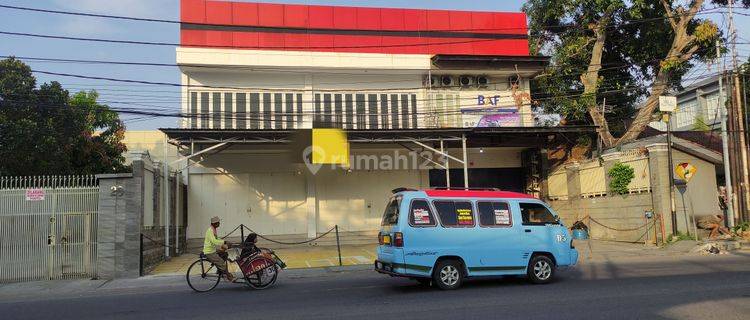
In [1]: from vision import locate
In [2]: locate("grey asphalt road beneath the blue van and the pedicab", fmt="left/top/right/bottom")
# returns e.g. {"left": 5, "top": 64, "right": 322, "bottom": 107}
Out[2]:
{"left": 0, "top": 253, "right": 750, "bottom": 320}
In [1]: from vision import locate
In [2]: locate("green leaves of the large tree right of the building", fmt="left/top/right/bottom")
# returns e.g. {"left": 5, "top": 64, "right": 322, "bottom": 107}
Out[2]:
{"left": 523, "top": 0, "right": 736, "bottom": 134}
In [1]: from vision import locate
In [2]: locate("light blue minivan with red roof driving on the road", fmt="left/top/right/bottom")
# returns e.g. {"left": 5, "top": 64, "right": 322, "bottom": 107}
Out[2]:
{"left": 375, "top": 188, "right": 578, "bottom": 289}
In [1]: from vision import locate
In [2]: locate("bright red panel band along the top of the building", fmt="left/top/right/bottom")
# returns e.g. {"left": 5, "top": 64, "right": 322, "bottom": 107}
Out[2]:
{"left": 180, "top": 0, "right": 529, "bottom": 56}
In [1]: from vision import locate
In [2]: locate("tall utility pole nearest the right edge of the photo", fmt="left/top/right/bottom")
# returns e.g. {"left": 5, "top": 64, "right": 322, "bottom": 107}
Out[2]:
{"left": 729, "top": 0, "right": 750, "bottom": 220}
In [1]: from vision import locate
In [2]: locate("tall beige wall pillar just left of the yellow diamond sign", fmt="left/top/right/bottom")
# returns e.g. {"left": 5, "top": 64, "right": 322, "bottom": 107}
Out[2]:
{"left": 646, "top": 143, "right": 672, "bottom": 235}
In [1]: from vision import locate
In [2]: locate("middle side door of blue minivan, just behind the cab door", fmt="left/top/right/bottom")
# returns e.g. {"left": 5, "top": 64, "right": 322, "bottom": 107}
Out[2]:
{"left": 478, "top": 200, "right": 526, "bottom": 275}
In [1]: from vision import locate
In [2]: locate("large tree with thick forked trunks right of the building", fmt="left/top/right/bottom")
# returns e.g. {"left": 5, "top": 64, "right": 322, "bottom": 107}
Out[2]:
{"left": 524, "top": 0, "right": 732, "bottom": 146}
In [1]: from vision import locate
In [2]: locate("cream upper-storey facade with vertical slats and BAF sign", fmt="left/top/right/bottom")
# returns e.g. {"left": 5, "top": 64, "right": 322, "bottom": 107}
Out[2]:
{"left": 182, "top": 67, "right": 535, "bottom": 129}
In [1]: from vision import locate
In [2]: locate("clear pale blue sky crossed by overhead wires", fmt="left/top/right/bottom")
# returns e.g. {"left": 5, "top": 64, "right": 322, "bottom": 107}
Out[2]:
{"left": 0, "top": 0, "right": 750, "bottom": 130}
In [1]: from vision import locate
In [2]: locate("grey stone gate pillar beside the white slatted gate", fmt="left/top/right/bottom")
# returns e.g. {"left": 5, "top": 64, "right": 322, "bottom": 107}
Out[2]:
{"left": 96, "top": 173, "right": 143, "bottom": 279}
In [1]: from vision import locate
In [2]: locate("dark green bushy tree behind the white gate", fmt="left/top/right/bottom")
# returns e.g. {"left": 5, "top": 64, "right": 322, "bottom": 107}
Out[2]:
{"left": 0, "top": 58, "right": 127, "bottom": 175}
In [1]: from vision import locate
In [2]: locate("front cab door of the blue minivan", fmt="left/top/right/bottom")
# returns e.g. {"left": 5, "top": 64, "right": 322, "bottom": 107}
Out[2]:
{"left": 518, "top": 201, "right": 569, "bottom": 265}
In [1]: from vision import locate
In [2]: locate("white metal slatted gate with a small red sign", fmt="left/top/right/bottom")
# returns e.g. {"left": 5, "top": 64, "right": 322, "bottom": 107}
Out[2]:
{"left": 0, "top": 176, "right": 99, "bottom": 282}
